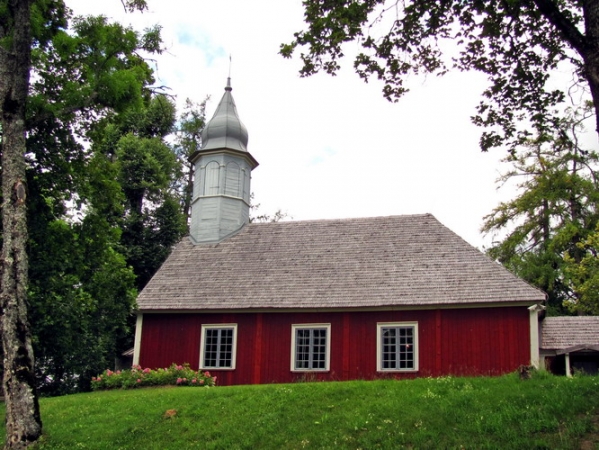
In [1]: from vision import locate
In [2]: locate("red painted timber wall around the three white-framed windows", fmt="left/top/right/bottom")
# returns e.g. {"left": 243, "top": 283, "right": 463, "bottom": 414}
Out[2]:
{"left": 139, "top": 307, "right": 530, "bottom": 385}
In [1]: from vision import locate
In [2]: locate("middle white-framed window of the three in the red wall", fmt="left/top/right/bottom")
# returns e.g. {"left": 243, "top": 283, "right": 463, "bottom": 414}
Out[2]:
{"left": 291, "top": 323, "right": 331, "bottom": 372}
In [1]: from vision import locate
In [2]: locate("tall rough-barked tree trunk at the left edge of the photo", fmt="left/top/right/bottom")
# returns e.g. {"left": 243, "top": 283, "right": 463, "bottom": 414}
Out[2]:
{"left": 0, "top": 0, "right": 42, "bottom": 449}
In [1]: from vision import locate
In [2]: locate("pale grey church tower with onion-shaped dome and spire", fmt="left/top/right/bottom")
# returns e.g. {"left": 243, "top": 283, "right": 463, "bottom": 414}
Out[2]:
{"left": 190, "top": 78, "right": 258, "bottom": 244}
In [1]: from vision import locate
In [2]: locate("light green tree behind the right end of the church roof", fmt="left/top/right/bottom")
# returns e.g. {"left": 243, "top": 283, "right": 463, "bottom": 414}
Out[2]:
{"left": 482, "top": 109, "right": 599, "bottom": 313}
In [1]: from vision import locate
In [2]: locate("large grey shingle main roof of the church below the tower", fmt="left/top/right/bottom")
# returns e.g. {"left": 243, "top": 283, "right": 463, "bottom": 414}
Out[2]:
{"left": 137, "top": 214, "right": 545, "bottom": 311}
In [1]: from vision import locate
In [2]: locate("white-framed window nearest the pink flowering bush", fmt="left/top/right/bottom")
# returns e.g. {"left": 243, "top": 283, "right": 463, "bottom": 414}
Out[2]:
{"left": 200, "top": 323, "right": 237, "bottom": 370}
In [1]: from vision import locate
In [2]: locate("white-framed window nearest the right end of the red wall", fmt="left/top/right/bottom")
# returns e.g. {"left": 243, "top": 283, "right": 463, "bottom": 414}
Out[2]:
{"left": 376, "top": 322, "right": 418, "bottom": 372}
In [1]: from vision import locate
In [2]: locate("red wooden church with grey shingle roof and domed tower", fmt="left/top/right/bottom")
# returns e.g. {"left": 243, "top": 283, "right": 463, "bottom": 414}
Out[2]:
{"left": 134, "top": 79, "right": 545, "bottom": 385}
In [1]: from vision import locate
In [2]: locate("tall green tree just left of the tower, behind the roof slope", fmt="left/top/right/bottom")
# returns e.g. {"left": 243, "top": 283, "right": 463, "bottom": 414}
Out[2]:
{"left": 93, "top": 95, "right": 186, "bottom": 290}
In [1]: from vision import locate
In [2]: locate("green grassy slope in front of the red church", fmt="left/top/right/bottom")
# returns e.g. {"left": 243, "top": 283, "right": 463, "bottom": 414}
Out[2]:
{"left": 2, "top": 373, "right": 599, "bottom": 450}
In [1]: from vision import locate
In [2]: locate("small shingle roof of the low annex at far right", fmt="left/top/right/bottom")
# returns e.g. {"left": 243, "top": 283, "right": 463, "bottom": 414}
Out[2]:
{"left": 541, "top": 316, "right": 599, "bottom": 350}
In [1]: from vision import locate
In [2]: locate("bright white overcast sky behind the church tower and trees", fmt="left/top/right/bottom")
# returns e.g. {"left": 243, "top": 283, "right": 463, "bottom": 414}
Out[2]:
{"left": 66, "top": 0, "right": 524, "bottom": 248}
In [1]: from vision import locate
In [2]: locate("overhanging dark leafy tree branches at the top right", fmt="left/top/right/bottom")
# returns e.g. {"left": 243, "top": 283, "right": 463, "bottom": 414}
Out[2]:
{"left": 281, "top": 0, "right": 599, "bottom": 151}
